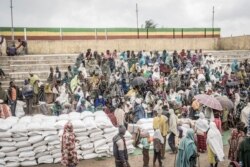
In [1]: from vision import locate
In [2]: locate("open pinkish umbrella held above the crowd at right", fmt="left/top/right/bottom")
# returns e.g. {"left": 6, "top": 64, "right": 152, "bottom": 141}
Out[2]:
{"left": 194, "top": 94, "right": 223, "bottom": 111}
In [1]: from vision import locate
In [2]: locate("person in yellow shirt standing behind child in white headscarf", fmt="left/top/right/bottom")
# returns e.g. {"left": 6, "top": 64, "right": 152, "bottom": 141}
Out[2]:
{"left": 153, "top": 108, "right": 168, "bottom": 159}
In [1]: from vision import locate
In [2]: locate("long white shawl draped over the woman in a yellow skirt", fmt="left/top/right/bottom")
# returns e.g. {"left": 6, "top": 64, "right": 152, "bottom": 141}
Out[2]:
{"left": 207, "top": 122, "right": 225, "bottom": 161}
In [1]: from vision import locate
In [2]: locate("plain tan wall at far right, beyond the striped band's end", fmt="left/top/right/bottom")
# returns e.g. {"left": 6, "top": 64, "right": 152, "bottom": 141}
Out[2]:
{"left": 218, "top": 35, "right": 250, "bottom": 50}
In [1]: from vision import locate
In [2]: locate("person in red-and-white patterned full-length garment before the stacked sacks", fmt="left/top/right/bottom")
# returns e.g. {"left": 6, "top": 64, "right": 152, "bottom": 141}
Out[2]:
{"left": 61, "top": 122, "right": 79, "bottom": 167}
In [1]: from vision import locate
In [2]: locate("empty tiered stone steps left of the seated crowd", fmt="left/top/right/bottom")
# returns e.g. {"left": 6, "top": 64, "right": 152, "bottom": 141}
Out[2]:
{"left": 0, "top": 54, "right": 78, "bottom": 89}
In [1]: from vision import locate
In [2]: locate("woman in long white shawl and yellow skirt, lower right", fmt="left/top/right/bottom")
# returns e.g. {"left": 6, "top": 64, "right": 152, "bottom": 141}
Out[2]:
{"left": 207, "top": 122, "right": 224, "bottom": 167}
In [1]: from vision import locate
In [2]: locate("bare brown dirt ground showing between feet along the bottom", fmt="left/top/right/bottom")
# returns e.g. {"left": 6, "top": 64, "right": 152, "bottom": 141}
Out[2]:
{"left": 38, "top": 146, "right": 229, "bottom": 167}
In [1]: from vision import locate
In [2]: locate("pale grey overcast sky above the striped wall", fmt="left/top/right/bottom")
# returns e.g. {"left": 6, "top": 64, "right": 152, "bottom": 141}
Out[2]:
{"left": 0, "top": 0, "right": 250, "bottom": 36}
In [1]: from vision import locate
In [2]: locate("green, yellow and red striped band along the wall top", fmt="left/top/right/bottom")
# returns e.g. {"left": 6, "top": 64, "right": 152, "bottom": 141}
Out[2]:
{"left": 0, "top": 27, "right": 220, "bottom": 40}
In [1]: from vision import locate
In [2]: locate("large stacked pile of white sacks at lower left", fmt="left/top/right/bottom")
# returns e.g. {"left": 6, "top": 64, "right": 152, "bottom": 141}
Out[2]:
{"left": 0, "top": 111, "right": 134, "bottom": 167}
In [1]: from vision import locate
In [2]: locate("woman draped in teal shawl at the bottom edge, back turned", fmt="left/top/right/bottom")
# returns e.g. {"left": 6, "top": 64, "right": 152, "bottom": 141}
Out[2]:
{"left": 176, "top": 129, "right": 197, "bottom": 167}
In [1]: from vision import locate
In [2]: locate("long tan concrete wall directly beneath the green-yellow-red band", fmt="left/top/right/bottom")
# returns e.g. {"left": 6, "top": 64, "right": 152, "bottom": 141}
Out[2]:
{"left": 28, "top": 38, "right": 218, "bottom": 54}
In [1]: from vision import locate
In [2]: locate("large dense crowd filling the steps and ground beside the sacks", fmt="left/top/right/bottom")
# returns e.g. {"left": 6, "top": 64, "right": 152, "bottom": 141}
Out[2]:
{"left": 0, "top": 49, "right": 250, "bottom": 167}
